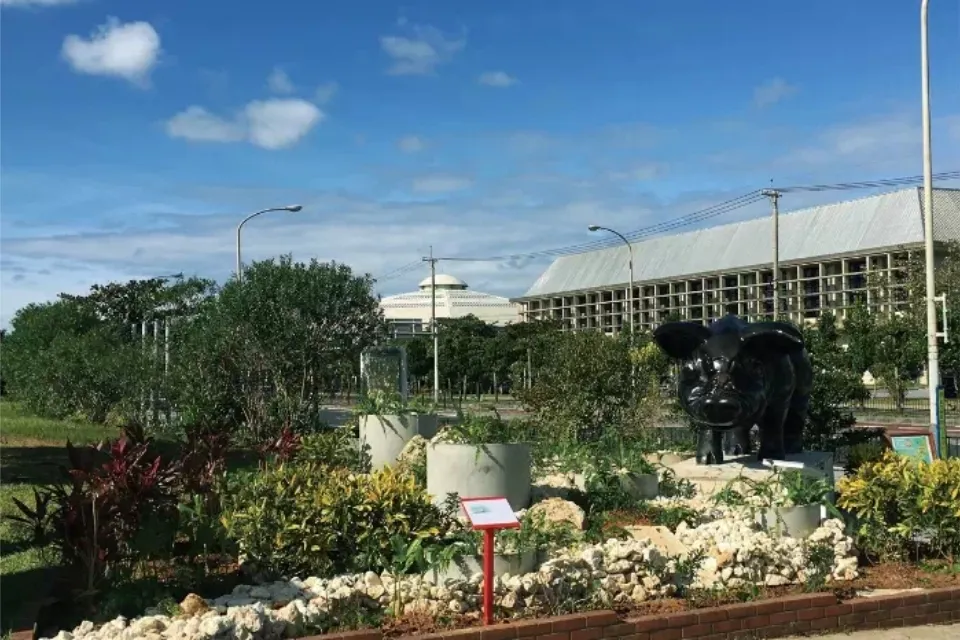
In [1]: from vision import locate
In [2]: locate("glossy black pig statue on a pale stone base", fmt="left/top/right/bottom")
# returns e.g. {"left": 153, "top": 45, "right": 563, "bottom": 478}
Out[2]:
{"left": 653, "top": 314, "right": 813, "bottom": 464}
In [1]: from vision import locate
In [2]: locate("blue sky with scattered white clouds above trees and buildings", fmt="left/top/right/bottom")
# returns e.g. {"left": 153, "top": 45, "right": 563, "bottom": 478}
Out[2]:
{"left": 0, "top": 0, "right": 960, "bottom": 325}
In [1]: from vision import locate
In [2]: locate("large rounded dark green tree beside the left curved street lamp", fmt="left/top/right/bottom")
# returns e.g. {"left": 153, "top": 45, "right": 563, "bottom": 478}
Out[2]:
{"left": 169, "top": 256, "right": 386, "bottom": 440}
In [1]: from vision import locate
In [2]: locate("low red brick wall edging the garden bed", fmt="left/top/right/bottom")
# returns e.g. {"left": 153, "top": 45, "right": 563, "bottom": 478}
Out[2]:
{"left": 305, "top": 587, "right": 960, "bottom": 640}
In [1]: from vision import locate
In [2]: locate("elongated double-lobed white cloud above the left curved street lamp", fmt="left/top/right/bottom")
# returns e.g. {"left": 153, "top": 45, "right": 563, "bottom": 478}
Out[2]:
{"left": 166, "top": 98, "right": 325, "bottom": 150}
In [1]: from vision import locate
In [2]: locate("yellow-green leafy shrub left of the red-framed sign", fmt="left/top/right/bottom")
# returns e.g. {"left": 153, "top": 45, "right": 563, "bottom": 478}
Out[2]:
{"left": 222, "top": 463, "right": 448, "bottom": 577}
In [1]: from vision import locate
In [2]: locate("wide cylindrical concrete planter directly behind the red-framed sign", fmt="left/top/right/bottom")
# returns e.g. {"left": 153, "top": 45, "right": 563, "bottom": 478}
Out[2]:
{"left": 427, "top": 442, "right": 531, "bottom": 511}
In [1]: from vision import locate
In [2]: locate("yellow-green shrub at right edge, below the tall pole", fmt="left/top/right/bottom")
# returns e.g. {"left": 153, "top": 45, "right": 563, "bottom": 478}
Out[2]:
{"left": 837, "top": 452, "right": 960, "bottom": 558}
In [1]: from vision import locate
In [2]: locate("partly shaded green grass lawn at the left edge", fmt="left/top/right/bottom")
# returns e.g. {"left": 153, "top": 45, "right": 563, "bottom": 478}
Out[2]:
{"left": 0, "top": 401, "right": 118, "bottom": 633}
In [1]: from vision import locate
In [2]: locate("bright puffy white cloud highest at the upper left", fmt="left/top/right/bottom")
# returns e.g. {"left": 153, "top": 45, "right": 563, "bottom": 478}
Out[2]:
{"left": 61, "top": 17, "right": 161, "bottom": 85}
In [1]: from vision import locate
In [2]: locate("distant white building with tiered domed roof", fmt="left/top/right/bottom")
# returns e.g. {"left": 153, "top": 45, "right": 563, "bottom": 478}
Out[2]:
{"left": 380, "top": 273, "right": 520, "bottom": 337}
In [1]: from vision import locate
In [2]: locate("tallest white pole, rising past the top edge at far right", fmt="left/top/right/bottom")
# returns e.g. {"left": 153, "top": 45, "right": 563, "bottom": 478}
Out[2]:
{"left": 920, "top": 0, "right": 941, "bottom": 442}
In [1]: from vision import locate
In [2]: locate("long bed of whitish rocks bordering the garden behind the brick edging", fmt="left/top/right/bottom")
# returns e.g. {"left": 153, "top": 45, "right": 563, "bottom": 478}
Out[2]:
{"left": 41, "top": 509, "right": 857, "bottom": 640}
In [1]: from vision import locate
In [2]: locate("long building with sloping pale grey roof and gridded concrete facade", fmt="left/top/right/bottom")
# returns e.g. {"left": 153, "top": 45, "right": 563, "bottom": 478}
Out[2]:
{"left": 514, "top": 188, "right": 960, "bottom": 333}
